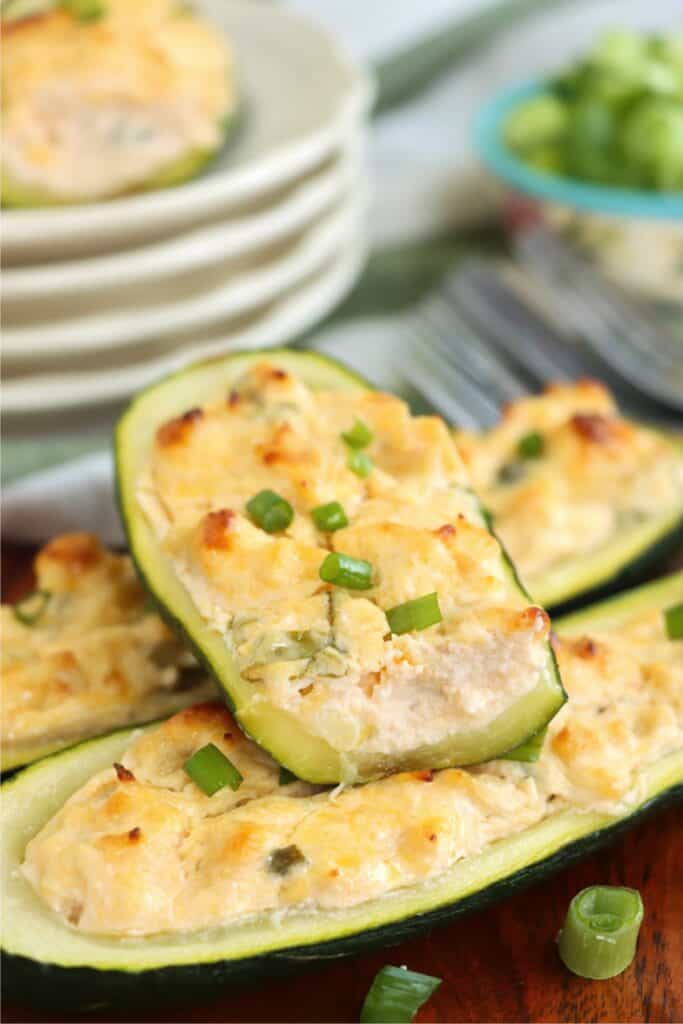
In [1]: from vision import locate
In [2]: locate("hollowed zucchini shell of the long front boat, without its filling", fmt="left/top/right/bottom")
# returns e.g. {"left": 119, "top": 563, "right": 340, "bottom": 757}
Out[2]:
{"left": 1, "top": 572, "right": 683, "bottom": 1009}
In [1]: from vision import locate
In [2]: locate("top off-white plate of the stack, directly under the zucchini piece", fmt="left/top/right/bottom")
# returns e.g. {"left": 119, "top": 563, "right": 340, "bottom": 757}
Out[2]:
{"left": 2, "top": 0, "right": 373, "bottom": 265}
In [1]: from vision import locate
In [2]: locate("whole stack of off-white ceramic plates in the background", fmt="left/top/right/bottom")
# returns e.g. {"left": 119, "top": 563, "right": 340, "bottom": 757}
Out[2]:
{"left": 2, "top": 0, "right": 372, "bottom": 415}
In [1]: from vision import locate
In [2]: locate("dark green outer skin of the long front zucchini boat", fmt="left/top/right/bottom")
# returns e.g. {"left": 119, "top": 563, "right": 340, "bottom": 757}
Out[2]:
{"left": 2, "top": 782, "right": 683, "bottom": 1013}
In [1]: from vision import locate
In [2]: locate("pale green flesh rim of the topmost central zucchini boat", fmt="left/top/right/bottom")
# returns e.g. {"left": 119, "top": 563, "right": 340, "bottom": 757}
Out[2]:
{"left": 116, "top": 349, "right": 565, "bottom": 783}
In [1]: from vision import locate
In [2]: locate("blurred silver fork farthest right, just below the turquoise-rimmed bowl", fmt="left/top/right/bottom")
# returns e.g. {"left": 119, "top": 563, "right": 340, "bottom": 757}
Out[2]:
{"left": 515, "top": 226, "right": 683, "bottom": 411}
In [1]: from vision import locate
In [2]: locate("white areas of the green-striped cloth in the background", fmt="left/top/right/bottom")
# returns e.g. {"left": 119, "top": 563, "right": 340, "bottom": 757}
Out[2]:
{"left": 3, "top": 0, "right": 682, "bottom": 543}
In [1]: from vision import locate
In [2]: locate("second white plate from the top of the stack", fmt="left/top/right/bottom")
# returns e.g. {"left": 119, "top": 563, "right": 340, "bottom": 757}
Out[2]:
{"left": 2, "top": 146, "right": 359, "bottom": 303}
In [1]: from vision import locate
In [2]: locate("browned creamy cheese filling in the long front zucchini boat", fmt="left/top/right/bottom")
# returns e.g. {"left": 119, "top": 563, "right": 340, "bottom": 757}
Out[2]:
{"left": 22, "top": 612, "right": 683, "bottom": 936}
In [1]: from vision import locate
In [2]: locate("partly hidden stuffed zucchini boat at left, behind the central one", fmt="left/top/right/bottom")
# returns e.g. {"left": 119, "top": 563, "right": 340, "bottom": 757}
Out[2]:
{"left": 0, "top": 534, "right": 215, "bottom": 771}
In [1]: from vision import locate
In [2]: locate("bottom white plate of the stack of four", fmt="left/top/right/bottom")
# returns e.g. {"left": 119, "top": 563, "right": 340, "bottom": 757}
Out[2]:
{"left": 2, "top": 229, "right": 367, "bottom": 417}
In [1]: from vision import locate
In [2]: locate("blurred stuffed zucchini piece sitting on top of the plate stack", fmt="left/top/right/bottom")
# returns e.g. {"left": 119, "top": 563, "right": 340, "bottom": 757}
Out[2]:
{"left": 2, "top": 0, "right": 237, "bottom": 207}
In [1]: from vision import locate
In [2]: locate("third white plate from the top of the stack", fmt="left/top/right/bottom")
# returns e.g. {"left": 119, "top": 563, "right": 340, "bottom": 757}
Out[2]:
{"left": 3, "top": 186, "right": 367, "bottom": 368}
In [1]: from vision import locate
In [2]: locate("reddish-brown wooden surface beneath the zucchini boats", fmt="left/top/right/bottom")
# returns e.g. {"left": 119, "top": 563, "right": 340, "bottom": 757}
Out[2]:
{"left": 3, "top": 546, "right": 683, "bottom": 1024}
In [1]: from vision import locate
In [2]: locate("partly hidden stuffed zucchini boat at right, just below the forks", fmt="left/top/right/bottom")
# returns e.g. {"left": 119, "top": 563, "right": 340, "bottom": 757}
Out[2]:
{"left": 456, "top": 380, "right": 683, "bottom": 608}
